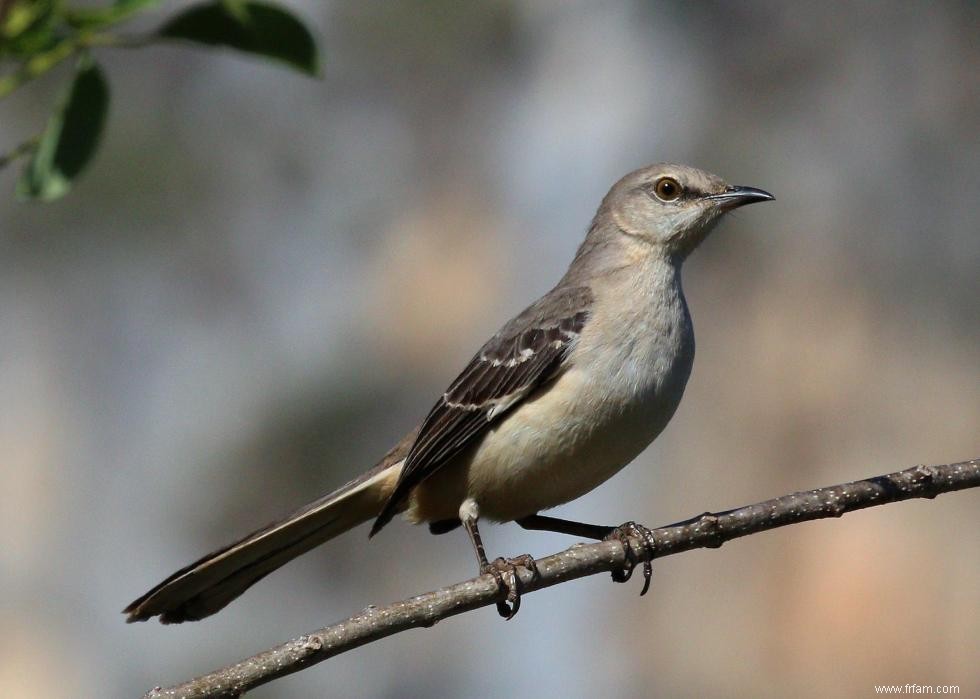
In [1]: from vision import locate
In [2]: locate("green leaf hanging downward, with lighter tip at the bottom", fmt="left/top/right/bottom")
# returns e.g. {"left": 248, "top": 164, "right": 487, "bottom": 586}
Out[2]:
{"left": 17, "top": 56, "right": 109, "bottom": 201}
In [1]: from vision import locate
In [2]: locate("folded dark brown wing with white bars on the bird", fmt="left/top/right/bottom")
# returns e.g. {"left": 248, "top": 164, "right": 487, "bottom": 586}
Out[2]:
{"left": 371, "top": 286, "right": 592, "bottom": 536}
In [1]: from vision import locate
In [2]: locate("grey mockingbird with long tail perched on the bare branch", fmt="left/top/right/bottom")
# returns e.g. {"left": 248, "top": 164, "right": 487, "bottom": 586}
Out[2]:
{"left": 123, "top": 163, "right": 775, "bottom": 624}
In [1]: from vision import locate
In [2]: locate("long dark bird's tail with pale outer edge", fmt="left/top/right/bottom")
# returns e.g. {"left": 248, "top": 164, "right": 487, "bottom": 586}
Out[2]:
{"left": 123, "top": 460, "right": 404, "bottom": 624}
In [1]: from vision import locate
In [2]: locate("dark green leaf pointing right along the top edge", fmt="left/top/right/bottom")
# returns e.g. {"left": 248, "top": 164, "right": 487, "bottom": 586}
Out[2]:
{"left": 157, "top": 0, "right": 319, "bottom": 75}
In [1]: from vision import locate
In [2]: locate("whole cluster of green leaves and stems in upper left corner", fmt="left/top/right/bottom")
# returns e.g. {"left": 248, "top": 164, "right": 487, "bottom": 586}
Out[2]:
{"left": 0, "top": 0, "right": 319, "bottom": 201}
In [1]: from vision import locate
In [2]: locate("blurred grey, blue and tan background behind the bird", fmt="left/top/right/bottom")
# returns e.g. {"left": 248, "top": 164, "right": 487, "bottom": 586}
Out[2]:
{"left": 0, "top": 0, "right": 980, "bottom": 697}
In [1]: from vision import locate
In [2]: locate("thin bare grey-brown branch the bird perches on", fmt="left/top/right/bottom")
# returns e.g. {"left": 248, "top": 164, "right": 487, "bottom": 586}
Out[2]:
{"left": 145, "top": 458, "right": 980, "bottom": 699}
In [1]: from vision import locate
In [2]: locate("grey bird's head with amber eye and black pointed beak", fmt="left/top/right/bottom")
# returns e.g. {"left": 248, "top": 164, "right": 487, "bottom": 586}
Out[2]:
{"left": 600, "top": 163, "right": 775, "bottom": 258}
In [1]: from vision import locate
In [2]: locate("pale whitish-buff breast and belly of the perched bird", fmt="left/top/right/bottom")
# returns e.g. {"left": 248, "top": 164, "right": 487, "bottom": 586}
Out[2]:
{"left": 466, "top": 262, "right": 694, "bottom": 521}
